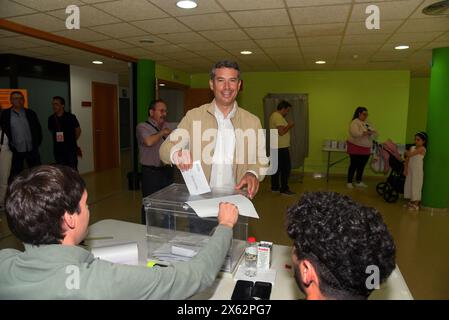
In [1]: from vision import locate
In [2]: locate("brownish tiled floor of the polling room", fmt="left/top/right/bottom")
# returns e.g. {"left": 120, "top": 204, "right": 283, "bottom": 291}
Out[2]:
{"left": 0, "top": 154, "right": 449, "bottom": 299}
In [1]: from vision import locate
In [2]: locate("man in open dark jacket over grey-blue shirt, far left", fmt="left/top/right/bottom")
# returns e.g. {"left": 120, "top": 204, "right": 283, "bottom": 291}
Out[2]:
{"left": 0, "top": 91, "right": 42, "bottom": 179}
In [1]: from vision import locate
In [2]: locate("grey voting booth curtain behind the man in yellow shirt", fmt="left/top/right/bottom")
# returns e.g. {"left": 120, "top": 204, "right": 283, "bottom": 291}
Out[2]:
{"left": 263, "top": 94, "right": 309, "bottom": 168}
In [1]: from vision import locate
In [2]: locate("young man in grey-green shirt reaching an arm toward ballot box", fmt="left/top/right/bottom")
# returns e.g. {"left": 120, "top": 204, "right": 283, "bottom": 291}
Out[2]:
{"left": 0, "top": 166, "right": 238, "bottom": 299}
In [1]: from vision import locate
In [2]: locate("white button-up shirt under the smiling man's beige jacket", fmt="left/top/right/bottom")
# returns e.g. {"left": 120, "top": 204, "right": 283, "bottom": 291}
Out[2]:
{"left": 209, "top": 102, "right": 236, "bottom": 189}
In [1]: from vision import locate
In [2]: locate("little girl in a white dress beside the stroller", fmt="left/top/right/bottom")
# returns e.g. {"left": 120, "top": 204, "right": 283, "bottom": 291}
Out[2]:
{"left": 404, "top": 132, "right": 427, "bottom": 211}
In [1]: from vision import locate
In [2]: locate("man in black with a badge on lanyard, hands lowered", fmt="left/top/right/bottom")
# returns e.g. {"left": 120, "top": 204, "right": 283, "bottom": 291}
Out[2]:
{"left": 48, "top": 96, "right": 81, "bottom": 170}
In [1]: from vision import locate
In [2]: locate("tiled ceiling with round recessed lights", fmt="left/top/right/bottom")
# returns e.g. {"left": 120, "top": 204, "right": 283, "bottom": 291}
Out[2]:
{"left": 0, "top": 0, "right": 449, "bottom": 75}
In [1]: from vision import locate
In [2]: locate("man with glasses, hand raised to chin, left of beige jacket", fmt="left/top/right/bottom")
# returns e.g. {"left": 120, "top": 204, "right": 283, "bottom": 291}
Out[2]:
{"left": 136, "top": 99, "right": 173, "bottom": 224}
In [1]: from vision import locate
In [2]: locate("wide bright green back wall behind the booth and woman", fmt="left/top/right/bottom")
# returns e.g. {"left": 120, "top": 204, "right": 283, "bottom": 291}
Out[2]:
{"left": 191, "top": 71, "right": 410, "bottom": 174}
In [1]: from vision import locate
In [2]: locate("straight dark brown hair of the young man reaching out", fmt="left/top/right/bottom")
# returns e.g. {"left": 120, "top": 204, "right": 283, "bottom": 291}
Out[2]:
{"left": 5, "top": 165, "right": 86, "bottom": 245}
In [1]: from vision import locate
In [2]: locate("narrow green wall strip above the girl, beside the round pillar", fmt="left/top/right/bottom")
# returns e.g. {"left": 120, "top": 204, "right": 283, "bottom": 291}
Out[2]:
{"left": 406, "top": 78, "right": 430, "bottom": 143}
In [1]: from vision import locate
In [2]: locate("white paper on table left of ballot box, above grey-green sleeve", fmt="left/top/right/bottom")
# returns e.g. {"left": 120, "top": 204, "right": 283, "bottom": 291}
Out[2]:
{"left": 91, "top": 242, "right": 139, "bottom": 265}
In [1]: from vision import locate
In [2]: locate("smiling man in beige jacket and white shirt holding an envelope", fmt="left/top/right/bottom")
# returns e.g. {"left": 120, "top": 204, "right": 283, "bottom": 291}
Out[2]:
{"left": 159, "top": 61, "right": 268, "bottom": 198}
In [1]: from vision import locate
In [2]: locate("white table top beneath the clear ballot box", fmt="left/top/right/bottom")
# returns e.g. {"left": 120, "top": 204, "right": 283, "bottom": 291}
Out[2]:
{"left": 88, "top": 219, "right": 413, "bottom": 300}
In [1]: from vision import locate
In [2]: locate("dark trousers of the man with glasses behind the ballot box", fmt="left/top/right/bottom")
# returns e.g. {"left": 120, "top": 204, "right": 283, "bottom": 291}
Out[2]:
{"left": 141, "top": 166, "right": 173, "bottom": 226}
